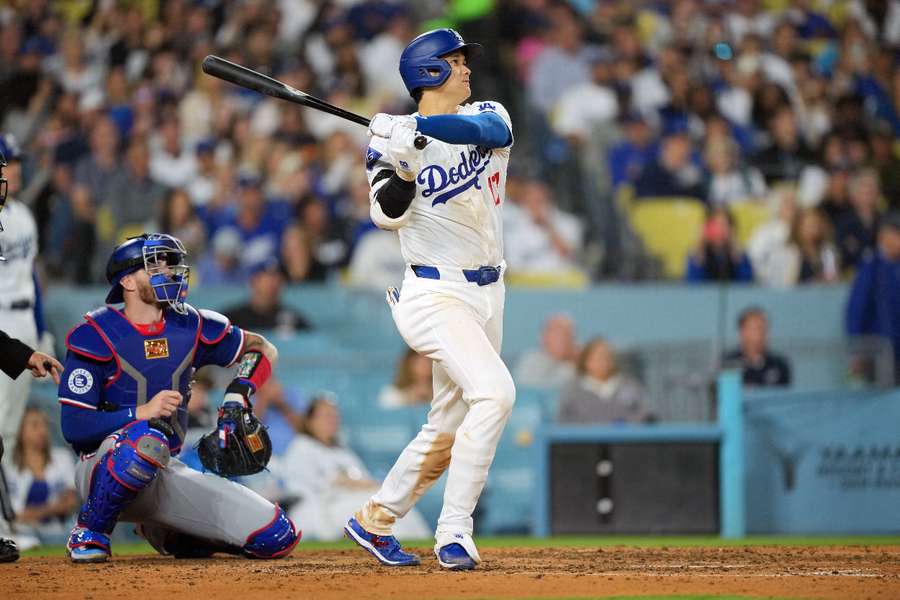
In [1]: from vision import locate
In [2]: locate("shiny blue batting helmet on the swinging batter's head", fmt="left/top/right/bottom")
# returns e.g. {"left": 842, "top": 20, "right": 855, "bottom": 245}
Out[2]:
{"left": 400, "top": 29, "right": 482, "bottom": 93}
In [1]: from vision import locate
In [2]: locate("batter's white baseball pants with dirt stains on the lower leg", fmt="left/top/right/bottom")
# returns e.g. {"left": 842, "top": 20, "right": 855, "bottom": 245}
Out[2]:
{"left": 356, "top": 268, "right": 516, "bottom": 537}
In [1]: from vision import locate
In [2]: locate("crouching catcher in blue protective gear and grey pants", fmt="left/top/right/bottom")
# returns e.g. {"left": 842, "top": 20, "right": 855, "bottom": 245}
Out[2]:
{"left": 59, "top": 233, "right": 300, "bottom": 563}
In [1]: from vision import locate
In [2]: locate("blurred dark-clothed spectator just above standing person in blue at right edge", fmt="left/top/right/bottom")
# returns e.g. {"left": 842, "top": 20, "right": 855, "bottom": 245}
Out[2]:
{"left": 835, "top": 169, "right": 881, "bottom": 267}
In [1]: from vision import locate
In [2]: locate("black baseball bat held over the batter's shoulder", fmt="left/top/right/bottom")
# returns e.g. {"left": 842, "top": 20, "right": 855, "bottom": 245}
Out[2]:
{"left": 202, "top": 54, "right": 427, "bottom": 150}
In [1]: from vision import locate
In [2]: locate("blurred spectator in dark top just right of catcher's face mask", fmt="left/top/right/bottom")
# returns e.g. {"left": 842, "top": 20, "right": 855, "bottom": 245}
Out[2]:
{"left": 223, "top": 258, "right": 311, "bottom": 336}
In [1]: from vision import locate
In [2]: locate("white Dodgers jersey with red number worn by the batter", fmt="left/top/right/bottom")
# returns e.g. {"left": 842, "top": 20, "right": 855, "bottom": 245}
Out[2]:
{"left": 366, "top": 102, "right": 512, "bottom": 269}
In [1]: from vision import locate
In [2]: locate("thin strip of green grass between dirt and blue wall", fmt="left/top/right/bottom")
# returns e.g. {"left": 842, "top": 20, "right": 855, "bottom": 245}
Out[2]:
{"left": 23, "top": 536, "right": 900, "bottom": 556}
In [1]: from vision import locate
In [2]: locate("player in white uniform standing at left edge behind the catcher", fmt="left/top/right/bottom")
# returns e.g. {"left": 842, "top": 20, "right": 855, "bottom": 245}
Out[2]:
{"left": 0, "top": 134, "right": 38, "bottom": 455}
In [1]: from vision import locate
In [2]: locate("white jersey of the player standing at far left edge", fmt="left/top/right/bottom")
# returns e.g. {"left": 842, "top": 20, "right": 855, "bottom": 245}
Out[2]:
{"left": 0, "top": 198, "right": 38, "bottom": 308}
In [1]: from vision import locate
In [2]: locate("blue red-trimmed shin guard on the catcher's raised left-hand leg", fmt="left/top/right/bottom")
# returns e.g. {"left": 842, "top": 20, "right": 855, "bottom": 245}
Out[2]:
{"left": 78, "top": 421, "right": 169, "bottom": 533}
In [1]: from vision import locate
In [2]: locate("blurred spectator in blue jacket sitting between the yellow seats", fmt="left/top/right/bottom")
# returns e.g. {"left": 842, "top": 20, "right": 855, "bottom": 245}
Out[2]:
{"left": 685, "top": 207, "right": 753, "bottom": 283}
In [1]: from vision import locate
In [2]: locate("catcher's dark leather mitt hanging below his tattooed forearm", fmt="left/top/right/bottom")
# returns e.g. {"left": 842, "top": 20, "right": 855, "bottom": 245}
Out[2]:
{"left": 197, "top": 384, "right": 272, "bottom": 477}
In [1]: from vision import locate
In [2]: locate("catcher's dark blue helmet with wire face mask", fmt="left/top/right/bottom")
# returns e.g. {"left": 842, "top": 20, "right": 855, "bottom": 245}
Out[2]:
{"left": 106, "top": 233, "right": 190, "bottom": 314}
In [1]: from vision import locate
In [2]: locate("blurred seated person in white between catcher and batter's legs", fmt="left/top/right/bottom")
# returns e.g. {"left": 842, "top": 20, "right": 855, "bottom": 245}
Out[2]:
{"left": 279, "top": 396, "right": 432, "bottom": 540}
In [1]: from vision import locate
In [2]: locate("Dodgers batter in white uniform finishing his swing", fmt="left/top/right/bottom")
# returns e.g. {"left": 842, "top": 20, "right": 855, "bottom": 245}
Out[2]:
{"left": 345, "top": 29, "right": 516, "bottom": 570}
